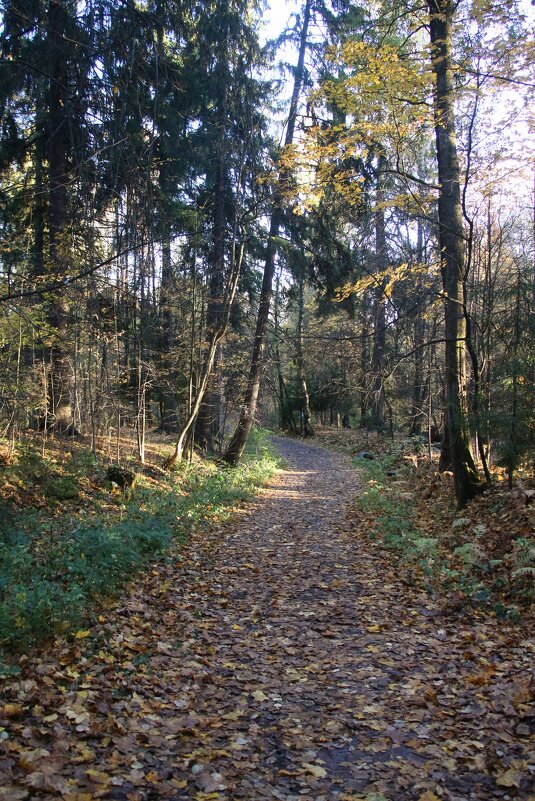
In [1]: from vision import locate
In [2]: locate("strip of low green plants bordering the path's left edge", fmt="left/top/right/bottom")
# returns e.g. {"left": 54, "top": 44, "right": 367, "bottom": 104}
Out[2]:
{"left": 0, "top": 431, "right": 278, "bottom": 655}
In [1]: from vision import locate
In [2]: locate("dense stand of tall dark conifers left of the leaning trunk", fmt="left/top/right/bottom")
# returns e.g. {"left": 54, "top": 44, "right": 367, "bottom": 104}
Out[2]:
{"left": 0, "top": 0, "right": 268, "bottom": 459}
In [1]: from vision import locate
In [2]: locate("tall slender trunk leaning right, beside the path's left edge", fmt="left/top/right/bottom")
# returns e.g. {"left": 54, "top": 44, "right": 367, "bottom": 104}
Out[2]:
{"left": 223, "top": 0, "right": 312, "bottom": 464}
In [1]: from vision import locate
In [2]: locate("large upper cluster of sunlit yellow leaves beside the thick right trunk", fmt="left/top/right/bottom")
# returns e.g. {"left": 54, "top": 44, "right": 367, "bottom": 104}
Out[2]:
{"left": 298, "top": 39, "right": 433, "bottom": 210}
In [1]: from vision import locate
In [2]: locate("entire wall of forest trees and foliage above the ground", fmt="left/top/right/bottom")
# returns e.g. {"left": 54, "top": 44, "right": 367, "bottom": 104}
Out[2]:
{"left": 0, "top": 0, "right": 535, "bottom": 505}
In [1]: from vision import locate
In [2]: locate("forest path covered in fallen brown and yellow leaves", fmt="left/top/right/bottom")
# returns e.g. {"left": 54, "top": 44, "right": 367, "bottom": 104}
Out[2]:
{"left": 0, "top": 439, "right": 535, "bottom": 801}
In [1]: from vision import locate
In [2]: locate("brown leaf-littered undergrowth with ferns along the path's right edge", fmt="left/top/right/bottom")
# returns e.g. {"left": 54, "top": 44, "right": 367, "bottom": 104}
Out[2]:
{"left": 355, "top": 445, "right": 535, "bottom": 618}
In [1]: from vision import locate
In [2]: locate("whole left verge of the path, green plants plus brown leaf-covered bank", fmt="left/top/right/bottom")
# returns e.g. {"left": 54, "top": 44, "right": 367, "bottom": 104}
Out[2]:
{"left": 0, "top": 430, "right": 278, "bottom": 657}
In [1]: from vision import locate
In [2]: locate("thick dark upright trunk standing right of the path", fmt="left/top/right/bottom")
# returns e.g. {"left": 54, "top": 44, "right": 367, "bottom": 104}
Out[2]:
{"left": 429, "top": 0, "right": 482, "bottom": 508}
